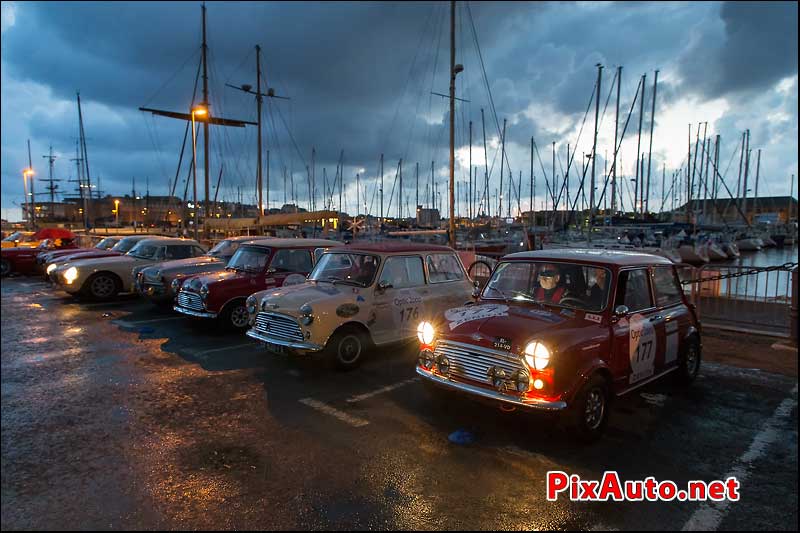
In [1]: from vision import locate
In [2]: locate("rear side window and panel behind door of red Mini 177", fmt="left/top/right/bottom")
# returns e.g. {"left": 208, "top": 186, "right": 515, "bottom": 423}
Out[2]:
{"left": 651, "top": 265, "right": 692, "bottom": 369}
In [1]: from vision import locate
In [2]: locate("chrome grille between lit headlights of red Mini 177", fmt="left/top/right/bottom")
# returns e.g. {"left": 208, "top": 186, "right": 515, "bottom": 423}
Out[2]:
{"left": 434, "top": 340, "right": 525, "bottom": 384}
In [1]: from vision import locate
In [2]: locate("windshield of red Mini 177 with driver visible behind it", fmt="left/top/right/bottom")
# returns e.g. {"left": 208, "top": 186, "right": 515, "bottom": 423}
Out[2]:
{"left": 482, "top": 261, "right": 611, "bottom": 312}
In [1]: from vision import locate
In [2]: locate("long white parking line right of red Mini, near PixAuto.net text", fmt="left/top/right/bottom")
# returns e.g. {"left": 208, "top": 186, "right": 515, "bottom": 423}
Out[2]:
{"left": 682, "top": 385, "right": 797, "bottom": 531}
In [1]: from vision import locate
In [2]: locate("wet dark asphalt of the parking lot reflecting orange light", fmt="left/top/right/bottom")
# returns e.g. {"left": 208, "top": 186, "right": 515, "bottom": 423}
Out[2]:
{"left": 2, "top": 278, "right": 797, "bottom": 530}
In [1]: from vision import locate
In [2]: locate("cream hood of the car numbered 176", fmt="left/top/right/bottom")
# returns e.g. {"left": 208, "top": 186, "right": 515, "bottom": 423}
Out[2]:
{"left": 256, "top": 281, "right": 360, "bottom": 315}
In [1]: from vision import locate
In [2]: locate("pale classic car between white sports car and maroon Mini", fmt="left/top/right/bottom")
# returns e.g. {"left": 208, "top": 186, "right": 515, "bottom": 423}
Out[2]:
{"left": 135, "top": 236, "right": 266, "bottom": 306}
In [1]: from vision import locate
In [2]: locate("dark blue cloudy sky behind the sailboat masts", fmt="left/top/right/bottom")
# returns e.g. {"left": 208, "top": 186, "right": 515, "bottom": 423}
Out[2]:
{"left": 0, "top": 2, "right": 798, "bottom": 220}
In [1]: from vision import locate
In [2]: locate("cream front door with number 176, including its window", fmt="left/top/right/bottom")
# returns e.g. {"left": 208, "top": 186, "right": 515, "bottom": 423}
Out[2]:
{"left": 371, "top": 255, "right": 429, "bottom": 344}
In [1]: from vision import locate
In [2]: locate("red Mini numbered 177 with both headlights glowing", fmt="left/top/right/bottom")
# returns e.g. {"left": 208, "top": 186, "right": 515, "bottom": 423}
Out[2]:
{"left": 417, "top": 249, "right": 701, "bottom": 440}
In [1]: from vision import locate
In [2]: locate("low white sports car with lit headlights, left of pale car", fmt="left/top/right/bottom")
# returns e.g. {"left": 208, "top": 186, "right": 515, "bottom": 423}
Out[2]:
{"left": 51, "top": 237, "right": 206, "bottom": 300}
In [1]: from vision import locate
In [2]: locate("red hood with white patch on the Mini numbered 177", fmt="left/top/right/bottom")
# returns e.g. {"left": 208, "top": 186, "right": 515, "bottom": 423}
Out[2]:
{"left": 436, "top": 301, "right": 607, "bottom": 353}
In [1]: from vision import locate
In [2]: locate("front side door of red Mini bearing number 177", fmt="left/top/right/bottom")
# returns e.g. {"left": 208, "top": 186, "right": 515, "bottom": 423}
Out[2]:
{"left": 612, "top": 267, "right": 664, "bottom": 392}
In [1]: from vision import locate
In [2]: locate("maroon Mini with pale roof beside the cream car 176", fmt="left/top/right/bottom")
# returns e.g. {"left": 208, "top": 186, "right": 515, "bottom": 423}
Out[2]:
{"left": 172, "top": 238, "right": 342, "bottom": 329}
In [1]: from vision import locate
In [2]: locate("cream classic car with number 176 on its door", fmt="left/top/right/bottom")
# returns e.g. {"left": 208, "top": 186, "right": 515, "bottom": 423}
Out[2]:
{"left": 247, "top": 243, "right": 472, "bottom": 369}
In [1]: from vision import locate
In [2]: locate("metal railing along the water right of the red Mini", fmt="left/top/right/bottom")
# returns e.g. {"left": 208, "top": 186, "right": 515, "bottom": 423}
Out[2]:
{"left": 680, "top": 265, "right": 797, "bottom": 342}
